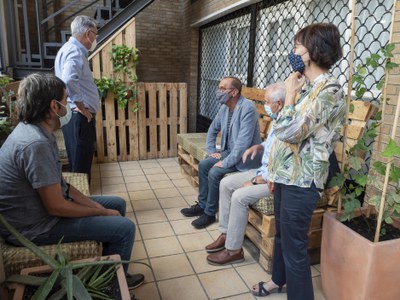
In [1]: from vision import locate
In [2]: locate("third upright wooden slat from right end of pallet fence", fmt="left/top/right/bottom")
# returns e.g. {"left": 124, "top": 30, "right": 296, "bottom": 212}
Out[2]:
{"left": 157, "top": 83, "right": 168, "bottom": 158}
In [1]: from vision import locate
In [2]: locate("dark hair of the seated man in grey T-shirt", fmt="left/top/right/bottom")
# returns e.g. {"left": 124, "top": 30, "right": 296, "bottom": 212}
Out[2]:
{"left": 17, "top": 73, "right": 65, "bottom": 123}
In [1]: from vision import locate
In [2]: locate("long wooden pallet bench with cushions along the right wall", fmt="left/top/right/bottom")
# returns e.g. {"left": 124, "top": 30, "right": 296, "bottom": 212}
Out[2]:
{"left": 178, "top": 84, "right": 376, "bottom": 273}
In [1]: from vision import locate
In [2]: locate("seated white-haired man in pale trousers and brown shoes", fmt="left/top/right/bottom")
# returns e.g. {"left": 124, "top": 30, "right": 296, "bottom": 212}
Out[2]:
{"left": 206, "top": 82, "right": 286, "bottom": 265}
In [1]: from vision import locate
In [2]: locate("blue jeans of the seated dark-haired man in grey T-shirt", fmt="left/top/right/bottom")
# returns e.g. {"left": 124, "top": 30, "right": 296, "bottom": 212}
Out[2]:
{"left": 32, "top": 196, "right": 135, "bottom": 272}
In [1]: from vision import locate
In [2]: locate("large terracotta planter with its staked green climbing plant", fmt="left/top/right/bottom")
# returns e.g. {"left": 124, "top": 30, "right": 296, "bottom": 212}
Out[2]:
{"left": 321, "top": 44, "right": 400, "bottom": 300}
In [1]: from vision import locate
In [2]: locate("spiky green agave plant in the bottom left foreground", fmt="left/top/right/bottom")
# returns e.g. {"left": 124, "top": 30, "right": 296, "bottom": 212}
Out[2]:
{"left": 0, "top": 214, "right": 125, "bottom": 300}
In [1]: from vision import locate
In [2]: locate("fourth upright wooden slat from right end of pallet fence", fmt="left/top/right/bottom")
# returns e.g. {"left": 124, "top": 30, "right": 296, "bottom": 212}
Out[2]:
{"left": 145, "top": 83, "right": 157, "bottom": 158}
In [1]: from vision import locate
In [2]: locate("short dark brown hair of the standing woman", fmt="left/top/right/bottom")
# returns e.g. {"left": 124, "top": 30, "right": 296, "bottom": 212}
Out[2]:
{"left": 293, "top": 23, "right": 343, "bottom": 69}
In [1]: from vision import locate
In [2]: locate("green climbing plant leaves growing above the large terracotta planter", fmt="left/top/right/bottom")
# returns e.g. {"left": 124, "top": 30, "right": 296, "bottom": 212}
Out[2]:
{"left": 331, "top": 44, "right": 400, "bottom": 237}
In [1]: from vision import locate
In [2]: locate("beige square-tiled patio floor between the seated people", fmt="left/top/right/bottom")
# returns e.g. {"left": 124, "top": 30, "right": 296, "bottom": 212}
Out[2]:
{"left": 91, "top": 158, "right": 324, "bottom": 300}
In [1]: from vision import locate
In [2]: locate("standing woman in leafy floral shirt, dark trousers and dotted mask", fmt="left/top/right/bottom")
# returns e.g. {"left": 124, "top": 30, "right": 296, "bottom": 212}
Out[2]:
{"left": 252, "top": 23, "right": 346, "bottom": 300}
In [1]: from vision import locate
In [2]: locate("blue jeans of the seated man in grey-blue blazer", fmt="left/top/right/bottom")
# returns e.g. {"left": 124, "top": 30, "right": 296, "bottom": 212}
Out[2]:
{"left": 198, "top": 157, "right": 237, "bottom": 216}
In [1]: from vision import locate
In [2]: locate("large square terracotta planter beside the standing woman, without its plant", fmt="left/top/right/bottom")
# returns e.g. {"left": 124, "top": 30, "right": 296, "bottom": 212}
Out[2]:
{"left": 321, "top": 212, "right": 400, "bottom": 300}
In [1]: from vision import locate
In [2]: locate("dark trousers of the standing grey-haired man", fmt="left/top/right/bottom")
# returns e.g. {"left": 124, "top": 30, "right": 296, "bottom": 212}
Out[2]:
{"left": 62, "top": 112, "right": 96, "bottom": 180}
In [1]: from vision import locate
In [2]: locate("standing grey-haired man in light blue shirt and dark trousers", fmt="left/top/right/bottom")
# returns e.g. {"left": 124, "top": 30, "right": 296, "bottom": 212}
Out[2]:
{"left": 55, "top": 16, "right": 100, "bottom": 179}
